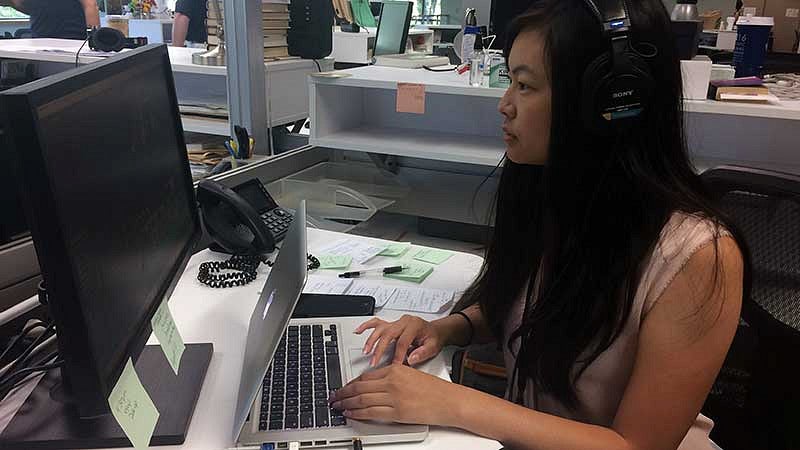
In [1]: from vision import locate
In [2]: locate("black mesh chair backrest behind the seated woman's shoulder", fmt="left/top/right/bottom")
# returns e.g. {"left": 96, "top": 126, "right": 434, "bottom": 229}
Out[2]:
{"left": 702, "top": 166, "right": 800, "bottom": 342}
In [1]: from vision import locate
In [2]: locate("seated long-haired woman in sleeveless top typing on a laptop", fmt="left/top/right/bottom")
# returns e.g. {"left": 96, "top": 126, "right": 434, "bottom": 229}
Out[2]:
{"left": 332, "top": 0, "right": 745, "bottom": 450}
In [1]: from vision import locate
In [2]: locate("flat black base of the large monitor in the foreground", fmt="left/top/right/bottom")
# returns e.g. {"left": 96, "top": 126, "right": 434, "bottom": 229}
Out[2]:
{"left": 0, "top": 344, "right": 214, "bottom": 450}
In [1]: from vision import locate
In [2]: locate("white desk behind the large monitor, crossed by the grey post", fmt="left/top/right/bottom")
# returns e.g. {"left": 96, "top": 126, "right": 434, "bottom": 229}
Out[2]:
{"left": 0, "top": 39, "right": 327, "bottom": 136}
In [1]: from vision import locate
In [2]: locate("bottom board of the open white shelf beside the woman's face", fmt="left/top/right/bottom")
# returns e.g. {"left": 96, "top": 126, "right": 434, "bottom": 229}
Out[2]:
{"left": 309, "top": 127, "right": 505, "bottom": 166}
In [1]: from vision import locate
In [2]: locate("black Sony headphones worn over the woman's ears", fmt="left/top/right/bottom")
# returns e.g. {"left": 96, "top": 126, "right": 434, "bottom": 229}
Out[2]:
{"left": 582, "top": 0, "right": 655, "bottom": 134}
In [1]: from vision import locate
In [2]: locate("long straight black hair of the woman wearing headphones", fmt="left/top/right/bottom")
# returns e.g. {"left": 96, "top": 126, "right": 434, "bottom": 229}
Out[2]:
{"left": 461, "top": 0, "right": 730, "bottom": 408}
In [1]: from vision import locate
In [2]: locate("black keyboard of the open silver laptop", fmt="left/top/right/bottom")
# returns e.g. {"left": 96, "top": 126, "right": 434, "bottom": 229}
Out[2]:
{"left": 258, "top": 325, "right": 347, "bottom": 431}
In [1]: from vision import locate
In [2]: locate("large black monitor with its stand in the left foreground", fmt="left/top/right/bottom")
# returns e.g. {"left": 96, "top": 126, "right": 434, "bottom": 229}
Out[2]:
{"left": 0, "top": 45, "right": 211, "bottom": 448}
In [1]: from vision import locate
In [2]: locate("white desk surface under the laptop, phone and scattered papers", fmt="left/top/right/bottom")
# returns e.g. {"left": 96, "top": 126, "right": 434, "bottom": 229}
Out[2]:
{"left": 0, "top": 229, "right": 501, "bottom": 450}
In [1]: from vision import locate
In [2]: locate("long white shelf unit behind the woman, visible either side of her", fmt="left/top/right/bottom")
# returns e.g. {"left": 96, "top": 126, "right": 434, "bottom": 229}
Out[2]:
{"left": 310, "top": 66, "right": 800, "bottom": 173}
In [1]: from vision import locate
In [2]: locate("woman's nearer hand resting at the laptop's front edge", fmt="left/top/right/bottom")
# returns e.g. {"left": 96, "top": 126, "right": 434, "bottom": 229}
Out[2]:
{"left": 331, "top": 364, "right": 468, "bottom": 426}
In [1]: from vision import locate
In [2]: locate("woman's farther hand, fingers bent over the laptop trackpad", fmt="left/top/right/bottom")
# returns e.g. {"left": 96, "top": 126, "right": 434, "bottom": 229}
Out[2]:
{"left": 355, "top": 314, "right": 444, "bottom": 367}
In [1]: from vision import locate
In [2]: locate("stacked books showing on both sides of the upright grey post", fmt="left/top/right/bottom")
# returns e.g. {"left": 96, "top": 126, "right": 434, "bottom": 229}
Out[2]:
{"left": 206, "top": 0, "right": 289, "bottom": 61}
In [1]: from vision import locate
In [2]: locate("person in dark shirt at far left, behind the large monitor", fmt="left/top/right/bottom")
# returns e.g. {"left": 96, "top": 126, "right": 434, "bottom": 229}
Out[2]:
{"left": 0, "top": 0, "right": 100, "bottom": 40}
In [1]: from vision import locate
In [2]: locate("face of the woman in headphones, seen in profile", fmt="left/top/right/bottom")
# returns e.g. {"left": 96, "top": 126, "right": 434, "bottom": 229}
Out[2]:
{"left": 498, "top": 31, "right": 550, "bottom": 165}
